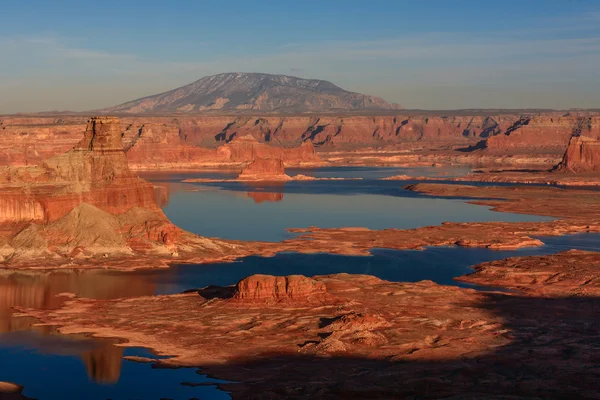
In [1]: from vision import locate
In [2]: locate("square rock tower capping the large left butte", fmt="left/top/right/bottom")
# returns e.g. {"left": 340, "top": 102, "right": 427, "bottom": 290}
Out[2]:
{"left": 73, "top": 117, "right": 123, "bottom": 151}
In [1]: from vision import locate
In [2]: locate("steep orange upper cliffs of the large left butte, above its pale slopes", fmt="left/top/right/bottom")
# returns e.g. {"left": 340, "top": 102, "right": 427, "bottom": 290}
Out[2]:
{"left": 0, "top": 117, "right": 158, "bottom": 227}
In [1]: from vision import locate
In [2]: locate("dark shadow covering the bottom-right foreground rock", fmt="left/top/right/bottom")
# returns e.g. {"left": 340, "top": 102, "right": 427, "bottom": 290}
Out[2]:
{"left": 206, "top": 293, "right": 600, "bottom": 399}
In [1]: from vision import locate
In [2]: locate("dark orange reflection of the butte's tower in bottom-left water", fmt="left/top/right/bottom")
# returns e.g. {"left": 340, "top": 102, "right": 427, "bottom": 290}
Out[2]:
{"left": 81, "top": 344, "right": 123, "bottom": 384}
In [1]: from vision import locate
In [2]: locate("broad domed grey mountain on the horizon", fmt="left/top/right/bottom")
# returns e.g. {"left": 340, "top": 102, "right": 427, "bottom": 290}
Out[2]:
{"left": 100, "top": 73, "right": 402, "bottom": 114}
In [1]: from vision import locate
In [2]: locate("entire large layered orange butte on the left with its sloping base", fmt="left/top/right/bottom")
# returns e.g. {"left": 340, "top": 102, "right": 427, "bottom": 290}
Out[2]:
{"left": 0, "top": 117, "right": 246, "bottom": 266}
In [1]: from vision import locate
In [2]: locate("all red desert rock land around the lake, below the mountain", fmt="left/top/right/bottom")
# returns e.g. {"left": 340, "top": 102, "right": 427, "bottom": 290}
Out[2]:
{"left": 0, "top": 108, "right": 600, "bottom": 399}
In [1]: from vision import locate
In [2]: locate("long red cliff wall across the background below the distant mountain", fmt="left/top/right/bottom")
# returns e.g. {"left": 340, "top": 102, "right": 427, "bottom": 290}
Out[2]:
{"left": 0, "top": 112, "right": 600, "bottom": 170}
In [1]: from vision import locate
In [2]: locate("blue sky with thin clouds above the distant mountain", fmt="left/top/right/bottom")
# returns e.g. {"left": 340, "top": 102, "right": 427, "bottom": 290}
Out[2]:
{"left": 0, "top": 0, "right": 600, "bottom": 113}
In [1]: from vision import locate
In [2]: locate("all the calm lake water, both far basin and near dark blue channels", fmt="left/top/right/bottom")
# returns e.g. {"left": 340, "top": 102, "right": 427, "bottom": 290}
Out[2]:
{"left": 0, "top": 168, "right": 600, "bottom": 400}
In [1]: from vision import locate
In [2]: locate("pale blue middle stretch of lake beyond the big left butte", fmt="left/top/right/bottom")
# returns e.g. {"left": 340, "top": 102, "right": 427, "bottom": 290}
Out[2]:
{"left": 145, "top": 167, "right": 550, "bottom": 242}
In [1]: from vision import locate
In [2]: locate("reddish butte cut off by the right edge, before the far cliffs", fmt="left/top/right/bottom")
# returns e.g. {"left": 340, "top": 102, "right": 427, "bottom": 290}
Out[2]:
{"left": 554, "top": 136, "right": 600, "bottom": 172}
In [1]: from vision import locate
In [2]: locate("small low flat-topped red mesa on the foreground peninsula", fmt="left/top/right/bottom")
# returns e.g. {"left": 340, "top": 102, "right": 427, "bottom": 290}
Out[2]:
{"left": 233, "top": 274, "right": 327, "bottom": 302}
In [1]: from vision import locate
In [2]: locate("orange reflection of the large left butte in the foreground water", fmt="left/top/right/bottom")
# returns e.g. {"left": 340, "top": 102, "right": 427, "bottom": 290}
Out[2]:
{"left": 0, "top": 270, "right": 156, "bottom": 383}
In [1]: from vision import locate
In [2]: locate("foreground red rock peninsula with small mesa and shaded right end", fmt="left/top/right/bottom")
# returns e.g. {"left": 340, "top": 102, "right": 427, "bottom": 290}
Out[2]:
{"left": 17, "top": 268, "right": 600, "bottom": 399}
